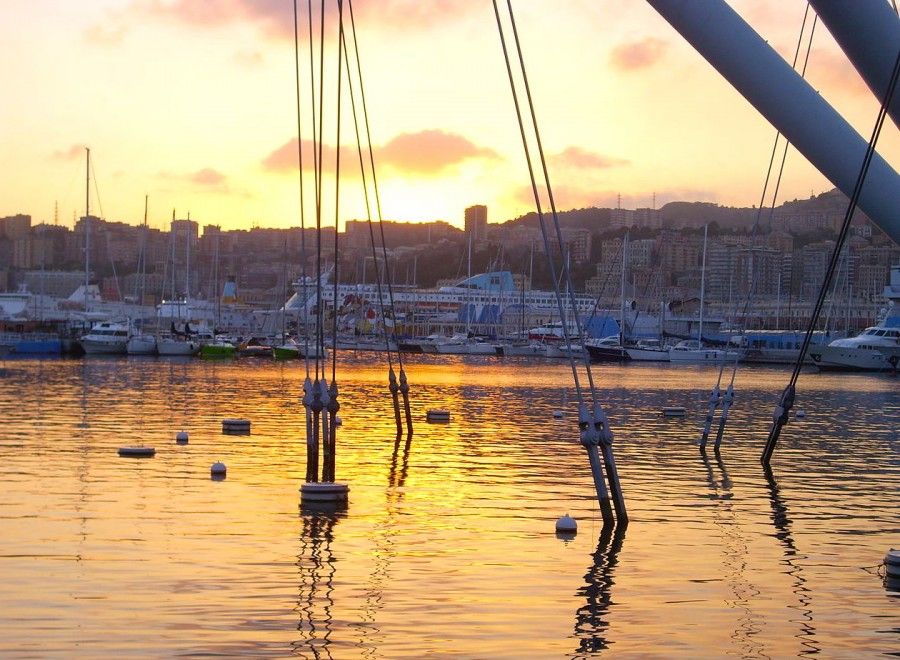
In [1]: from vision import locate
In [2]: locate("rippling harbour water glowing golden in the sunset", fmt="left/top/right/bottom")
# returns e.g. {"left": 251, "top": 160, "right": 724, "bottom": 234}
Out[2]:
{"left": 0, "top": 355, "right": 900, "bottom": 658}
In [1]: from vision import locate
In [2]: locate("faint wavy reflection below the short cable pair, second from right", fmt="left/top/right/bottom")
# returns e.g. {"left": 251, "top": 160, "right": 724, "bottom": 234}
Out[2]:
{"left": 700, "top": 448, "right": 763, "bottom": 656}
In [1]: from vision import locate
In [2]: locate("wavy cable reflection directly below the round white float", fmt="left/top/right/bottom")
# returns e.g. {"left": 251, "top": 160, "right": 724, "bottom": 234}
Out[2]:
{"left": 291, "top": 512, "right": 343, "bottom": 659}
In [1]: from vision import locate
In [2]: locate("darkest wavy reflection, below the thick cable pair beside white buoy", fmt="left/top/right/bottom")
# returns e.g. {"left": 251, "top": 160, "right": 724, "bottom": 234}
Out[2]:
{"left": 575, "top": 525, "right": 626, "bottom": 655}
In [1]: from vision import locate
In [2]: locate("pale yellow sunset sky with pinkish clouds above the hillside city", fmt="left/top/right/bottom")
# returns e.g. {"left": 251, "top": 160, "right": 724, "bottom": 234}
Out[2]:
{"left": 0, "top": 0, "right": 900, "bottom": 233}
